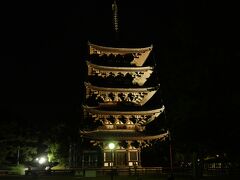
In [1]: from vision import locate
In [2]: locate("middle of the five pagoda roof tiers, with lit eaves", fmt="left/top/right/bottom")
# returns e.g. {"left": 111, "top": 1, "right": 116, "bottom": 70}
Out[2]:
{"left": 85, "top": 82, "right": 160, "bottom": 106}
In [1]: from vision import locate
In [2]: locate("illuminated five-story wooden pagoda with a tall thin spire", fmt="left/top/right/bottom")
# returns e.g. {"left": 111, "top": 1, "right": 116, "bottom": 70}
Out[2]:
{"left": 80, "top": 2, "right": 168, "bottom": 167}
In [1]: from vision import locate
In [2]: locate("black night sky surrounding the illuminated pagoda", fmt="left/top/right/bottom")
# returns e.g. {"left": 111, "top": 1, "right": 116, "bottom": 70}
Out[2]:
{"left": 0, "top": 0, "right": 240, "bottom": 153}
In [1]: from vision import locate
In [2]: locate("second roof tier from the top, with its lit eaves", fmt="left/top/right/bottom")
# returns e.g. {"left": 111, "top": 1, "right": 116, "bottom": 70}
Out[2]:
{"left": 87, "top": 61, "right": 153, "bottom": 86}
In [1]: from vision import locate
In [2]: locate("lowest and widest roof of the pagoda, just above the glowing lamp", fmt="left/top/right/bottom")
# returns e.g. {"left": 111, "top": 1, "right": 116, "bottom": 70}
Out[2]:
{"left": 80, "top": 130, "right": 168, "bottom": 141}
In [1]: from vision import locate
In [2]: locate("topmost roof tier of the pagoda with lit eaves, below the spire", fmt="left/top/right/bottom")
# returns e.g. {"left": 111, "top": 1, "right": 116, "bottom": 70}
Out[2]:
{"left": 88, "top": 43, "right": 153, "bottom": 66}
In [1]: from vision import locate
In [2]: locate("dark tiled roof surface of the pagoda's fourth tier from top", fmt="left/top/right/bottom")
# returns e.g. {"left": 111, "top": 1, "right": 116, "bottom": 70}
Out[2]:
{"left": 83, "top": 105, "right": 165, "bottom": 115}
